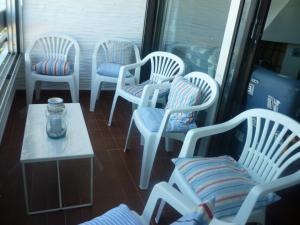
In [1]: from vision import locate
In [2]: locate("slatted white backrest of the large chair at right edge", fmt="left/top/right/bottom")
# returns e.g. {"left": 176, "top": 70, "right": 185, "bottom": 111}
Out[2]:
{"left": 239, "top": 109, "right": 300, "bottom": 183}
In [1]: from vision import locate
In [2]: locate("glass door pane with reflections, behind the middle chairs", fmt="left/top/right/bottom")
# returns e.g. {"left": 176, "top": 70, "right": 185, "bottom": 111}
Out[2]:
{"left": 160, "top": 0, "right": 231, "bottom": 76}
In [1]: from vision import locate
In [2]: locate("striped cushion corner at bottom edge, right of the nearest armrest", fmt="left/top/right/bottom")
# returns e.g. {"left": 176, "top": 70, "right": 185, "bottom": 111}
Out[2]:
{"left": 171, "top": 201, "right": 214, "bottom": 225}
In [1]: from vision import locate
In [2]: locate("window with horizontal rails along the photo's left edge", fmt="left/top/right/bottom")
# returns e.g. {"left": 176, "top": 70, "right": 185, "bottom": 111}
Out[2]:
{"left": 0, "top": 0, "right": 22, "bottom": 140}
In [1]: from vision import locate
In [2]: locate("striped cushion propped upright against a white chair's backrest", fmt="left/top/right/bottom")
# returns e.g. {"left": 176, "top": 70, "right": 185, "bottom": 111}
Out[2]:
{"left": 166, "top": 77, "right": 201, "bottom": 126}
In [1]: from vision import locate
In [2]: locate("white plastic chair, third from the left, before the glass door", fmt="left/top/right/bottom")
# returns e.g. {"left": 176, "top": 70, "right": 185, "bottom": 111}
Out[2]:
{"left": 108, "top": 51, "right": 184, "bottom": 126}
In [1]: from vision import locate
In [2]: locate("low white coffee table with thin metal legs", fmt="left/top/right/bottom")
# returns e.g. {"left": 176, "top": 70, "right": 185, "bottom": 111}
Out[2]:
{"left": 20, "top": 103, "right": 94, "bottom": 214}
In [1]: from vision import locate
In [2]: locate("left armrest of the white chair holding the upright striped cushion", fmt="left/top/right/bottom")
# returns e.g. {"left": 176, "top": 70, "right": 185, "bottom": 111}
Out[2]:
{"left": 140, "top": 83, "right": 171, "bottom": 107}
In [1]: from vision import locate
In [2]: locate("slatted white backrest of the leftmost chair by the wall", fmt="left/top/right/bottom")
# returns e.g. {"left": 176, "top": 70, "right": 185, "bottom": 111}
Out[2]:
{"left": 34, "top": 34, "right": 79, "bottom": 60}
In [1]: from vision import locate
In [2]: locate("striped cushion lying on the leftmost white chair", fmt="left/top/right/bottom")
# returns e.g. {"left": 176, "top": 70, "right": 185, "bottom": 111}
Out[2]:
{"left": 32, "top": 59, "right": 72, "bottom": 76}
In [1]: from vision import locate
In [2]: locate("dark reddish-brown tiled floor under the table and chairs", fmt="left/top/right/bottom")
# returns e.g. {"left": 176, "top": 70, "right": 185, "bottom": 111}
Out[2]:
{"left": 0, "top": 91, "right": 300, "bottom": 225}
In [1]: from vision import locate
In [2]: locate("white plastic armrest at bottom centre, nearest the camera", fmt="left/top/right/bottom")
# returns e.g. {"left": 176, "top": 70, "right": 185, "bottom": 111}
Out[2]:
{"left": 142, "top": 182, "right": 198, "bottom": 224}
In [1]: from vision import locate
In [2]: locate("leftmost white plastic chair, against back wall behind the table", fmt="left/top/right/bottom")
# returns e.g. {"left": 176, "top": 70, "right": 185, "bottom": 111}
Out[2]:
{"left": 25, "top": 34, "right": 80, "bottom": 104}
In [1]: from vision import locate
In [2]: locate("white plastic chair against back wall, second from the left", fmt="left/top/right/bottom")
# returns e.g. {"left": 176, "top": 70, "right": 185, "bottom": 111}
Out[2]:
{"left": 90, "top": 39, "right": 141, "bottom": 111}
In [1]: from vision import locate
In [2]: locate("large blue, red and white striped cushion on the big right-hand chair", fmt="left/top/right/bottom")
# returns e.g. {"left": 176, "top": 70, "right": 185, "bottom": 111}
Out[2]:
{"left": 173, "top": 156, "right": 279, "bottom": 218}
